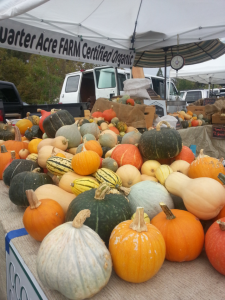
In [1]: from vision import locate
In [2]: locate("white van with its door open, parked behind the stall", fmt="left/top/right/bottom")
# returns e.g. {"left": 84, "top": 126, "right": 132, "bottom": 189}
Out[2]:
{"left": 59, "top": 67, "right": 181, "bottom": 109}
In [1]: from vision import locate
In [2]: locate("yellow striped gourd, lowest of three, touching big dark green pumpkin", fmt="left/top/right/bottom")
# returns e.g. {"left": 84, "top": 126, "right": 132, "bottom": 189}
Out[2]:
{"left": 70, "top": 178, "right": 99, "bottom": 196}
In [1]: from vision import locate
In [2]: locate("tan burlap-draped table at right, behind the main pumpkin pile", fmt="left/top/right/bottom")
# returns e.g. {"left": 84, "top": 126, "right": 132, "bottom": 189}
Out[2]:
{"left": 178, "top": 125, "right": 225, "bottom": 158}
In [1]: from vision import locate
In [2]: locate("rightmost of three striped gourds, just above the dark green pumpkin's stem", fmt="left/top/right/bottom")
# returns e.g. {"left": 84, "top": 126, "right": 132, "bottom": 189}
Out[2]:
{"left": 94, "top": 168, "right": 122, "bottom": 188}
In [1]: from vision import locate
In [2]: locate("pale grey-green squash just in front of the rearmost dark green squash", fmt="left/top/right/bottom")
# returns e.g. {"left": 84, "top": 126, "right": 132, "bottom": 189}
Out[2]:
{"left": 55, "top": 123, "right": 81, "bottom": 150}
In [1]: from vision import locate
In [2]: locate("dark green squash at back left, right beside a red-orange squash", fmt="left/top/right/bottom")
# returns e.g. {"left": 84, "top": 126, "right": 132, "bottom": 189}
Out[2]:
{"left": 43, "top": 109, "right": 75, "bottom": 138}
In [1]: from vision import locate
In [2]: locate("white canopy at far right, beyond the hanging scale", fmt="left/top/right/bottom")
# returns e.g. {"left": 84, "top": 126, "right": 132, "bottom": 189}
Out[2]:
{"left": 170, "top": 55, "right": 225, "bottom": 84}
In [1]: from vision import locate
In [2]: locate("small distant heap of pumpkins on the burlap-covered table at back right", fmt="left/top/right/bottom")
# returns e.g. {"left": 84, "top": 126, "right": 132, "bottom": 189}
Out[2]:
{"left": 169, "top": 110, "right": 210, "bottom": 128}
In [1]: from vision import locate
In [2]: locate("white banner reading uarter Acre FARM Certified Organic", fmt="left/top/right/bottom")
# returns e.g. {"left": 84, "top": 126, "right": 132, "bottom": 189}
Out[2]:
{"left": 0, "top": 19, "right": 135, "bottom": 68}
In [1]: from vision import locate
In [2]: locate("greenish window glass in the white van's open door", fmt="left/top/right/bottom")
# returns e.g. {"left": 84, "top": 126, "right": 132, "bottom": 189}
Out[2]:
{"left": 95, "top": 68, "right": 116, "bottom": 90}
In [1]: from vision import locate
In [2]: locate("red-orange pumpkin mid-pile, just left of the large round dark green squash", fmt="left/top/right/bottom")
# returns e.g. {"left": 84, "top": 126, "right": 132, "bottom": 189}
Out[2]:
{"left": 111, "top": 144, "right": 143, "bottom": 169}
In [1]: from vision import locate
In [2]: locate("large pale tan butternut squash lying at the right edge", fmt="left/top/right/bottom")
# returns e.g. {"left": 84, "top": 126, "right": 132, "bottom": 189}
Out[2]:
{"left": 165, "top": 172, "right": 225, "bottom": 220}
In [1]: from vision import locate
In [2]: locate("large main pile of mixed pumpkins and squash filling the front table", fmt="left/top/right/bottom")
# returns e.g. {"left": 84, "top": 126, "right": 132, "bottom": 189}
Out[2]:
{"left": 0, "top": 108, "right": 225, "bottom": 300}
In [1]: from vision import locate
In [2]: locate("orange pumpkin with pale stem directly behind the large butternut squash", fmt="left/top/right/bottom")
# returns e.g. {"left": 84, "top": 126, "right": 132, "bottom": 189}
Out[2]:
{"left": 188, "top": 149, "right": 225, "bottom": 184}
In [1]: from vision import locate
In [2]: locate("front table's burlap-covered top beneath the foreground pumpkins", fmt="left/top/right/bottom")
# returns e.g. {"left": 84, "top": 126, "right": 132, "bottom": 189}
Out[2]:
{"left": 0, "top": 180, "right": 225, "bottom": 300}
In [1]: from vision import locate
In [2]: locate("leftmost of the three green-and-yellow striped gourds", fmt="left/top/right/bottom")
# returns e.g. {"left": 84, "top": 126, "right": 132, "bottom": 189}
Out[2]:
{"left": 46, "top": 156, "right": 73, "bottom": 175}
